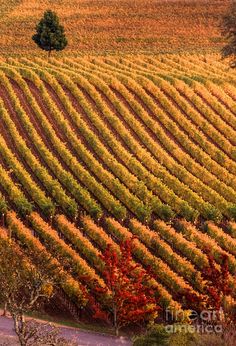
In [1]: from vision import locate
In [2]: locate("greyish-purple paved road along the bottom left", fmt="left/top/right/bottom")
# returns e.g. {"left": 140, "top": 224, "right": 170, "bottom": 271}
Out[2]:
{"left": 0, "top": 316, "right": 132, "bottom": 346}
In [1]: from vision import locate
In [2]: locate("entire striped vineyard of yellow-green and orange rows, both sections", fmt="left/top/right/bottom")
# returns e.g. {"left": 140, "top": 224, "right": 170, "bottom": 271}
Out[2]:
{"left": 0, "top": 54, "right": 236, "bottom": 318}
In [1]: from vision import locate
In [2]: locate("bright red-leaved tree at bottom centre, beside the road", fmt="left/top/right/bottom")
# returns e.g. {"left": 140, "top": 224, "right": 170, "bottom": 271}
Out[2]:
{"left": 94, "top": 240, "right": 160, "bottom": 335}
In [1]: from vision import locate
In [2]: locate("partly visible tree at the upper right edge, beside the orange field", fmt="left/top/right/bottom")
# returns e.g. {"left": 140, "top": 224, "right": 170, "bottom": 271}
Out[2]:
{"left": 220, "top": 1, "right": 236, "bottom": 68}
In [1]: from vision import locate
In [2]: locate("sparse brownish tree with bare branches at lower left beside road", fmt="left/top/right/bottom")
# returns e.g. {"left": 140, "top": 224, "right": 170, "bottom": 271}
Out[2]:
{"left": 0, "top": 237, "right": 58, "bottom": 346}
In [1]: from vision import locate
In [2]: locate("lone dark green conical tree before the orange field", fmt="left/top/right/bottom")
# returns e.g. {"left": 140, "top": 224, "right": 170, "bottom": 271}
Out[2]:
{"left": 32, "top": 10, "right": 68, "bottom": 57}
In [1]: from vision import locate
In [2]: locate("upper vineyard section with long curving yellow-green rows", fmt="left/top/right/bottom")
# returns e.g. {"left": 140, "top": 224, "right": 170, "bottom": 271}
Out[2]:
{"left": 0, "top": 56, "right": 236, "bottom": 221}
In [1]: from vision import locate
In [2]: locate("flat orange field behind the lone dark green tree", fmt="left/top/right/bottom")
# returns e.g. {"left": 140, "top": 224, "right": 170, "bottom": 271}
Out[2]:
{"left": 0, "top": 0, "right": 230, "bottom": 56}
